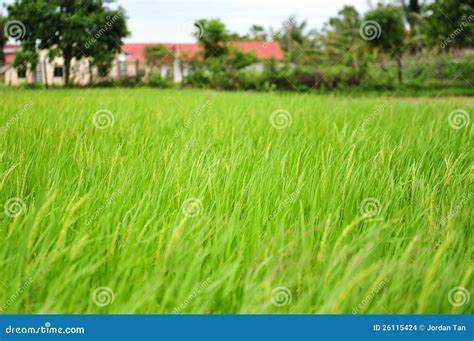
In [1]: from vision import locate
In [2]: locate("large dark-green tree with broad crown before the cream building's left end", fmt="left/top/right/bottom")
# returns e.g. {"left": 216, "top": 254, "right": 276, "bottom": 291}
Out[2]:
{"left": 8, "top": 0, "right": 128, "bottom": 85}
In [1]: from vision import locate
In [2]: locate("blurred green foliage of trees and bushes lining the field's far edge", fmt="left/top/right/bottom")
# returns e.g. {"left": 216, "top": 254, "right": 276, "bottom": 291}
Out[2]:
{"left": 0, "top": 0, "right": 474, "bottom": 91}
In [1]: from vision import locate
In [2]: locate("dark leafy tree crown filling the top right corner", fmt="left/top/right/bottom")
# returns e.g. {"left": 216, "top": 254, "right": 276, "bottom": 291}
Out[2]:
{"left": 425, "top": 0, "right": 474, "bottom": 50}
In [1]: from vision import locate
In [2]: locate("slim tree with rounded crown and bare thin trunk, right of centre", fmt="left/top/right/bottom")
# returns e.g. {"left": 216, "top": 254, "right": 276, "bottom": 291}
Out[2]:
{"left": 362, "top": 4, "right": 405, "bottom": 84}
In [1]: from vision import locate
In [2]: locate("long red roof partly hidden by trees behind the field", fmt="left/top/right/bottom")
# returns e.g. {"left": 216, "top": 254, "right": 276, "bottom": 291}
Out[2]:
{"left": 122, "top": 41, "right": 283, "bottom": 62}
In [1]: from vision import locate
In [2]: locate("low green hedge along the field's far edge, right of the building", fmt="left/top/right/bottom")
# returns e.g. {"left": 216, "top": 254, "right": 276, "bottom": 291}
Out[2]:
{"left": 185, "top": 49, "right": 474, "bottom": 92}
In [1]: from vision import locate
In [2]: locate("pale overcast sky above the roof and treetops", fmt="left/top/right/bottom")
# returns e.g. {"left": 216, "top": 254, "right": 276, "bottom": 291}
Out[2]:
{"left": 0, "top": 0, "right": 375, "bottom": 42}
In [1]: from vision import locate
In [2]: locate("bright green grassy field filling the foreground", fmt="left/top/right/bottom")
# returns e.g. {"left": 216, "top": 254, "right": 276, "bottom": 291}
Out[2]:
{"left": 0, "top": 89, "right": 474, "bottom": 314}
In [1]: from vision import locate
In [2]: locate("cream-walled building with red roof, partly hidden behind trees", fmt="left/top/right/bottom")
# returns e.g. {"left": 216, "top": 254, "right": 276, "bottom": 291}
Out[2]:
{"left": 0, "top": 41, "right": 283, "bottom": 85}
